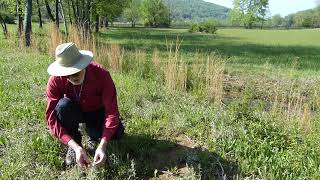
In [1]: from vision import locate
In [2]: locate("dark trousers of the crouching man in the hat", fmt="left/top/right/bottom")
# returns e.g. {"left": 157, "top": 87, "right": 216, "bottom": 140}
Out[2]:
{"left": 55, "top": 98, "right": 124, "bottom": 145}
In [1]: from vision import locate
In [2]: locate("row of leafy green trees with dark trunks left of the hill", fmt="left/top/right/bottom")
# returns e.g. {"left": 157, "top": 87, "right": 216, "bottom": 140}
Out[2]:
{"left": 0, "top": 0, "right": 170, "bottom": 46}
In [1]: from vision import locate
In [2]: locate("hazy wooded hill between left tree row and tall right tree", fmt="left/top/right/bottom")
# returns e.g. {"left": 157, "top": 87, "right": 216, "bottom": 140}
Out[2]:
{"left": 166, "top": 0, "right": 230, "bottom": 21}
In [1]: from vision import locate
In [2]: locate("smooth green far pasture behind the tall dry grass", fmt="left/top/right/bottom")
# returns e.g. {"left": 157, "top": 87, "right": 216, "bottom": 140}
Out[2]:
{"left": 99, "top": 28, "right": 320, "bottom": 77}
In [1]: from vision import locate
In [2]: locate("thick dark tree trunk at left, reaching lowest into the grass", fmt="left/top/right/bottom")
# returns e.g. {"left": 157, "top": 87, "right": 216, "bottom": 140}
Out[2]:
{"left": 24, "top": 0, "right": 32, "bottom": 47}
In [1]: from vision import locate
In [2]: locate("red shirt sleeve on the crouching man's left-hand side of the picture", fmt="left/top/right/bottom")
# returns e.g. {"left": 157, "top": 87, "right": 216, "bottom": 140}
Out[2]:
{"left": 46, "top": 76, "right": 71, "bottom": 144}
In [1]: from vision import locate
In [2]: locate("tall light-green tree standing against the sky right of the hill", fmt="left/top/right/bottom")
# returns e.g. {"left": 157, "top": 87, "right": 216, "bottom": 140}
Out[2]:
{"left": 230, "top": 0, "right": 269, "bottom": 29}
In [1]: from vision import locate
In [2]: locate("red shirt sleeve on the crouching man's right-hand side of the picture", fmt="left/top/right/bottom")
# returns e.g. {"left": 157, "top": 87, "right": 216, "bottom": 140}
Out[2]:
{"left": 102, "top": 71, "right": 119, "bottom": 141}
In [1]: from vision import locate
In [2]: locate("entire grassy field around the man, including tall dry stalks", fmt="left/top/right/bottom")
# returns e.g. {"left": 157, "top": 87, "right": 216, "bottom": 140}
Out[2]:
{"left": 0, "top": 28, "right": 320, "bottom": 179}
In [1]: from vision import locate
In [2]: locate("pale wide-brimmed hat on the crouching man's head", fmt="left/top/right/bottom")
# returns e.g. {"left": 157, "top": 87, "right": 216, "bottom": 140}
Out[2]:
{"left": 47, "top": 42, "right": 93, "bottom": 76}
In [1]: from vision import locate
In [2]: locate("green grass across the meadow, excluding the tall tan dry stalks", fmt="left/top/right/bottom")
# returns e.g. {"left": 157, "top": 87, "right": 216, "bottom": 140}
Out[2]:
{"left": 0, "top": 28, "right": 320, "bottom": 179}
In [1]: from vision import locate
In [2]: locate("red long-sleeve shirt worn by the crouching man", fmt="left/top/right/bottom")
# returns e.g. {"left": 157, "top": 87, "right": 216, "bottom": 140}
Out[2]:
{"left": 46, "top": 62, "right": 119, "bottom": 144}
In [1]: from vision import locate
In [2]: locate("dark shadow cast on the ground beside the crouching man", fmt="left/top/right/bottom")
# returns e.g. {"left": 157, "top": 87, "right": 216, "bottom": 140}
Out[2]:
{"left": 106, "top": 134, "right": 239, "bottom": 179}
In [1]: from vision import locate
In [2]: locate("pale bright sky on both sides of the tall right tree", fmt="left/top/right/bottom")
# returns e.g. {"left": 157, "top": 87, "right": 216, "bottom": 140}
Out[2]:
{"left": 205, "top": 0, "right": 316, "bottom": 16}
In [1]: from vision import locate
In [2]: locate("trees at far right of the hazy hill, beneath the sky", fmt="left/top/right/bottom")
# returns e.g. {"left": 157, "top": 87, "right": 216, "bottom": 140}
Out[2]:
{"left": 229, "top": 0, "right": 320, "bottom": 29}
